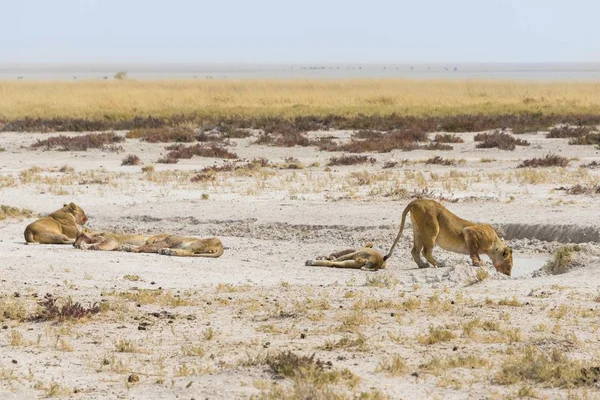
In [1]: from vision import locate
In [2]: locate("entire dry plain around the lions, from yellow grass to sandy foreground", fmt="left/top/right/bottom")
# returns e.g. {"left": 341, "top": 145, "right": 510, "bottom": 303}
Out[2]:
{"left": 0, "top": 80, "right": 600, "bottom": 399}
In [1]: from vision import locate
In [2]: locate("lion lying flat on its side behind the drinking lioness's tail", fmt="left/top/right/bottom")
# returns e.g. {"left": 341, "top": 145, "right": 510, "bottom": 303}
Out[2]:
{"left": 304, "top": 243, "right": 385, "bottom": 271}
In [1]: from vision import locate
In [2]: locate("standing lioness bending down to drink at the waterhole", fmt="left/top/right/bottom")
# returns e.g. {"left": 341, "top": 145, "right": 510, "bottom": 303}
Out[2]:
{"left": 383, "top": 199, "right": 513, "bottom": 276}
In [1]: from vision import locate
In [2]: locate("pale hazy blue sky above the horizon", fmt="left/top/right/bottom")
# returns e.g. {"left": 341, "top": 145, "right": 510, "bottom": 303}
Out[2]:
{"left": 0, "top": 0, "right": 600, "bottom": 64}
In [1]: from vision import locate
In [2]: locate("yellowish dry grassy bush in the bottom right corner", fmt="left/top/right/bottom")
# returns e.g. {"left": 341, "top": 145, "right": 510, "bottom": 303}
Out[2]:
{"left": 494, "top": 346, "right": 600, "bottom": 388}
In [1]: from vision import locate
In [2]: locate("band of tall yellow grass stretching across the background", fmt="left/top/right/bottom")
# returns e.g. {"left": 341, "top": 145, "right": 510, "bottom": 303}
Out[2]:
{"left": 0, "top": 79, "right": 600, "bottom": 120}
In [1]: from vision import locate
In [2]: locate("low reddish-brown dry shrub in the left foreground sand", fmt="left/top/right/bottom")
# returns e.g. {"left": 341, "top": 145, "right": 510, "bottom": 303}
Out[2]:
{"left": 29, "top": 293, "right": 100, "bottom": 322}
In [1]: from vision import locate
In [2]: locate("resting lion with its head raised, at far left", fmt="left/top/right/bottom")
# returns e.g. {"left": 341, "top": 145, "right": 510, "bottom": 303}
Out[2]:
{"left": 24, "top": 203, "right": 87, "bottom": 244}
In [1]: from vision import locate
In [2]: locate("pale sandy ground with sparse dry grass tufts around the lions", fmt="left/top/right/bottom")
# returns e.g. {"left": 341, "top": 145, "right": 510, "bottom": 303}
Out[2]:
{"left": 0, "top": 131, "right": 600, "bottom": 399}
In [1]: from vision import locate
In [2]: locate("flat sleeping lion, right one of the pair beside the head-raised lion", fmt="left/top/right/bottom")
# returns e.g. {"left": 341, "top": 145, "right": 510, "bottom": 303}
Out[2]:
{"left": 122, "top": 235, "right": 223, "bottom": 258}
